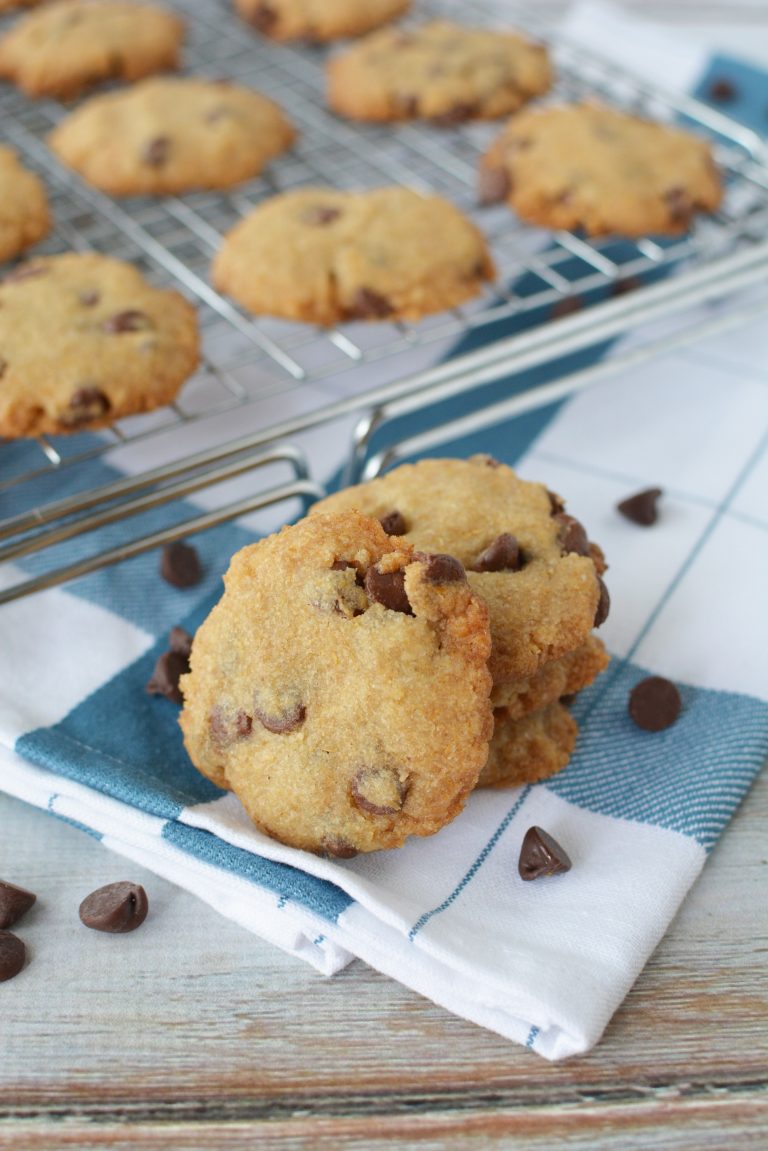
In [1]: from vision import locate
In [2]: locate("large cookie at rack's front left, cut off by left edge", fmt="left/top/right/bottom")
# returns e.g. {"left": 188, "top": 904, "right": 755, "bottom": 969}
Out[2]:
{"left": 0, "top": 252, "right": 198, "bottom": 437}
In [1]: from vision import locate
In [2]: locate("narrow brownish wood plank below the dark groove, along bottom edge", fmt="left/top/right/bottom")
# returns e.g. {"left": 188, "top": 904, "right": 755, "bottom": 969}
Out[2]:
{"left": 0, "top": 1092, "right": 768, "bottom": 1151}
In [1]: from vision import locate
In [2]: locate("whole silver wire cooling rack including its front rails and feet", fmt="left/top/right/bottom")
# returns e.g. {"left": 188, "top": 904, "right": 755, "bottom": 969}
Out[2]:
{"left": 0, "top": 0, "right": 768, "bottom": 602}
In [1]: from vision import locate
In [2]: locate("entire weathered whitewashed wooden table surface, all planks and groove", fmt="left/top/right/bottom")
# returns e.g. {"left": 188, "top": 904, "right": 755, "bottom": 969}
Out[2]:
{"left": 0, "top": 0, "right": 768, "bottom": 1151}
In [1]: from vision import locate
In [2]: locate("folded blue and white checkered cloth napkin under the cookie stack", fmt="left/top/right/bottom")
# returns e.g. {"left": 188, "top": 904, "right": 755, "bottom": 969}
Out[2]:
{"left": 0, "top": 2, "right": 768, "bottom": 1059}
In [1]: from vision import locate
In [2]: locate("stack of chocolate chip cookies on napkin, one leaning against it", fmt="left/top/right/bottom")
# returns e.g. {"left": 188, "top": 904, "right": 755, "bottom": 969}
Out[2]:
{"left": 181, "top": 456, "right": 608, "bottom": 857}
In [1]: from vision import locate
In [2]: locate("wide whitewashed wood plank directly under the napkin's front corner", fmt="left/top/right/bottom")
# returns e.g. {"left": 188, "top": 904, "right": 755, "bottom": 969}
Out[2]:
{"left": 0, "top": 777, "right": 768, "bottom": 1110}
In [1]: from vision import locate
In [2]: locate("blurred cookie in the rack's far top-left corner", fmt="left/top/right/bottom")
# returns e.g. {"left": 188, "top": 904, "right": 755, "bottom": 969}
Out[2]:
{"left": 0, "top": 0, "right": 184, "bottom": 99}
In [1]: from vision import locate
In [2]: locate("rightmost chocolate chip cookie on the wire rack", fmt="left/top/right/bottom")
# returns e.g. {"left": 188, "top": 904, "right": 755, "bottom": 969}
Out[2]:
{"left": 479, "top": 104, "right": 722, "bottom": 236}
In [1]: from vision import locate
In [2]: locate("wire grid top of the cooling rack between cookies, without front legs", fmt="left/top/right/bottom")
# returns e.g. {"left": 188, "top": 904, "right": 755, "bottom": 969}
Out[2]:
{"left": 0, "top": 0, "right": 768, "bottom": 504}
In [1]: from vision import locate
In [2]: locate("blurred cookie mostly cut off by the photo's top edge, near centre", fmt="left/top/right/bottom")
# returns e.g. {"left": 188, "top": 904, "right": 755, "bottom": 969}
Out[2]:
{"left": 235, "top": 0, "right": 410, "bottom": 41}
